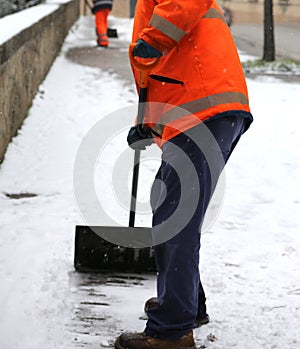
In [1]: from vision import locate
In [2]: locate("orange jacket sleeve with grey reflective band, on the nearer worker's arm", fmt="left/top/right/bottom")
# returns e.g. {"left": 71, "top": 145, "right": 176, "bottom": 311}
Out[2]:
{"left": 140, "top": 0, "right": 213, "bottom": 55}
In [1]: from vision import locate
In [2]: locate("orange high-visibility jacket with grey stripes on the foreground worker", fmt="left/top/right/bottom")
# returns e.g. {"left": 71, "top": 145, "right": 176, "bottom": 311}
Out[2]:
{"left": 132, "top": 0, "right": 250, "bottom": 144}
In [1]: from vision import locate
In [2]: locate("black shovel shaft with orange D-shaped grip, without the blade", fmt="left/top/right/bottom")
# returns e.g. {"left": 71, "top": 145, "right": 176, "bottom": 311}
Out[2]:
{"left": 129, "top": 43, "right": 159, "bottom": 227}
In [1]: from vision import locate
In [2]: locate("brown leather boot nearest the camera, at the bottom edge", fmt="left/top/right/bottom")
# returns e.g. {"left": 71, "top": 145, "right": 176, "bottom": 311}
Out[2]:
{"left": 115, "top": 331, "right": 196, "bottom": 349}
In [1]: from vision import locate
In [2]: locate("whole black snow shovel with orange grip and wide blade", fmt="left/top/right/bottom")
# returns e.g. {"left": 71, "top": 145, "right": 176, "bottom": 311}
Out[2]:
{"left": 74, "top": 44, "right": 159, "bottom": 273}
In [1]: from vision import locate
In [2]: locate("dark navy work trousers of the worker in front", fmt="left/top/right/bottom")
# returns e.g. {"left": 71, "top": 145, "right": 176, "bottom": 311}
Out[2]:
{"left": 145, "top": 114, "right": 247, "bottom": 340}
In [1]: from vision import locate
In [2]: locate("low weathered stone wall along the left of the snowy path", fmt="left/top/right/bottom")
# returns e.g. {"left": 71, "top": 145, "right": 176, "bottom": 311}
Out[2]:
{"left": 0, "top": 0, "right": 79, "bottom": 162}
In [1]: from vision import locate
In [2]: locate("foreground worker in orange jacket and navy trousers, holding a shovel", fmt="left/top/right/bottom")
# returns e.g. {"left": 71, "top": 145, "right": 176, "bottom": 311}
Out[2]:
{"left": 115, "top": 0, "right": 253, "bottom": 349}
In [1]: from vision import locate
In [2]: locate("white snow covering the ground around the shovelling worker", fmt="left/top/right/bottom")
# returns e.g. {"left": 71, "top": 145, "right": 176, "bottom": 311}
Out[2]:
{"left": 0, "top": 13, "right": 300, "bottom": 349}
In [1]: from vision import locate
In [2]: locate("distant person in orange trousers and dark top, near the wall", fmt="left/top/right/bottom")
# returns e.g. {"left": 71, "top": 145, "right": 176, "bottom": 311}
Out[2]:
{"left": 92, "top": 0, "right": 113, "bottom": 47}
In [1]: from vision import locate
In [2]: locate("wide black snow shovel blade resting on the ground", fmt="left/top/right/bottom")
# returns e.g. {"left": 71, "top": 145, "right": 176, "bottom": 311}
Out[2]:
{"left": 74, "top": 225, "right": 156, "bottom": 273}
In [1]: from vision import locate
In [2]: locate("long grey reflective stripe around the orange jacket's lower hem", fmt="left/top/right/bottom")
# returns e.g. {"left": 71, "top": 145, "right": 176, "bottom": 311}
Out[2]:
{"left": 152, "top": 92, "right": 249, "bottom": 135}
